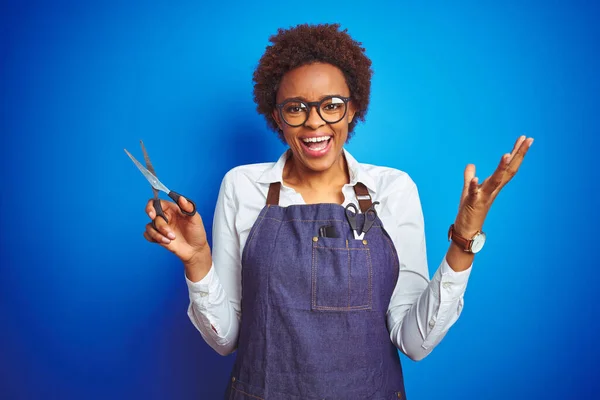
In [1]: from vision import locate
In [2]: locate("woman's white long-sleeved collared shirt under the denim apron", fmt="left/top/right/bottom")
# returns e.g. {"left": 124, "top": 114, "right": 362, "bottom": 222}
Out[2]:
{"left": 186, "top": 150, "right": 471, "bottom": 360}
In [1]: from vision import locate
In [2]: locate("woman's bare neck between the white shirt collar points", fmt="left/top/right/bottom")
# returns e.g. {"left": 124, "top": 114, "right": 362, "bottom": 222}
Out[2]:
{"left": 283, "top": 151, "right": 350, "bottom": 190}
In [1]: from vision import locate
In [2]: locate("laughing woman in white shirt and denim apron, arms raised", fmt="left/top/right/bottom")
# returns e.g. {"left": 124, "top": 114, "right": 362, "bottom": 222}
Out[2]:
{"left": 144, "top": 25, "right": 533, "bottom": 399}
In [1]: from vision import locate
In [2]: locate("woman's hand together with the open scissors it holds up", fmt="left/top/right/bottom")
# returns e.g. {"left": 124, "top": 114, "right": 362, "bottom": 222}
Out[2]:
{"left": 125, "top": 141, "right": 208, "bottom": 263}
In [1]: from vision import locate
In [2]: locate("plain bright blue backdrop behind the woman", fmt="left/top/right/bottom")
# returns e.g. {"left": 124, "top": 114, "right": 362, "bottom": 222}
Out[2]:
{"left": 0, "top": 1, "right": 600, "bottom": 399}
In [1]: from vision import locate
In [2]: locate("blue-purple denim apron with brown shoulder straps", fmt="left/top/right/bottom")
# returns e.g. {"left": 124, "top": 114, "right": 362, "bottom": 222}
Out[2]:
{"left": 226, "top": 183, "right": 405, "bottom": 400}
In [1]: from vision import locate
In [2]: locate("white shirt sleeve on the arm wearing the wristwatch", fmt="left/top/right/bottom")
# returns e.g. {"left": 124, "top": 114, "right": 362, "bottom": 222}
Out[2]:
{"left": 387, "top": 181, "right": 471, "bottom": 361}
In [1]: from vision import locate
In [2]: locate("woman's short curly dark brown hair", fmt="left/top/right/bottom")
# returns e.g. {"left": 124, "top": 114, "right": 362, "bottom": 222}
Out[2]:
{"left": 253, "top": 24, "right": 373, "bottom": 143}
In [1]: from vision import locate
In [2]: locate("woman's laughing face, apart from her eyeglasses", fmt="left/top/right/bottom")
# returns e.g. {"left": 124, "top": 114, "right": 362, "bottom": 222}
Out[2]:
{"left": 273, "top": 63, "right": 355, "bottom": 172}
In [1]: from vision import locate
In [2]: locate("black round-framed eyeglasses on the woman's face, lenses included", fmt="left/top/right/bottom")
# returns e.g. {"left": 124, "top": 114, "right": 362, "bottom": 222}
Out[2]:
{"left": 276, "top": 96, "right": 350, "bottom": 128}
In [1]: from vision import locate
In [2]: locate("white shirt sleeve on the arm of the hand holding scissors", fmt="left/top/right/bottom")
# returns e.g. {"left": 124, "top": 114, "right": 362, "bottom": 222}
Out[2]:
{"left": 186, "top": 173, "right": 241, "bottom": 355}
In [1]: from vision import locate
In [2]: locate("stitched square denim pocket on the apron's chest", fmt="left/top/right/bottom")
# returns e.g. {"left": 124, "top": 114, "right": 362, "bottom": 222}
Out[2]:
{"left": 311, "top": 237, "right": 373, "bottom": 311}
